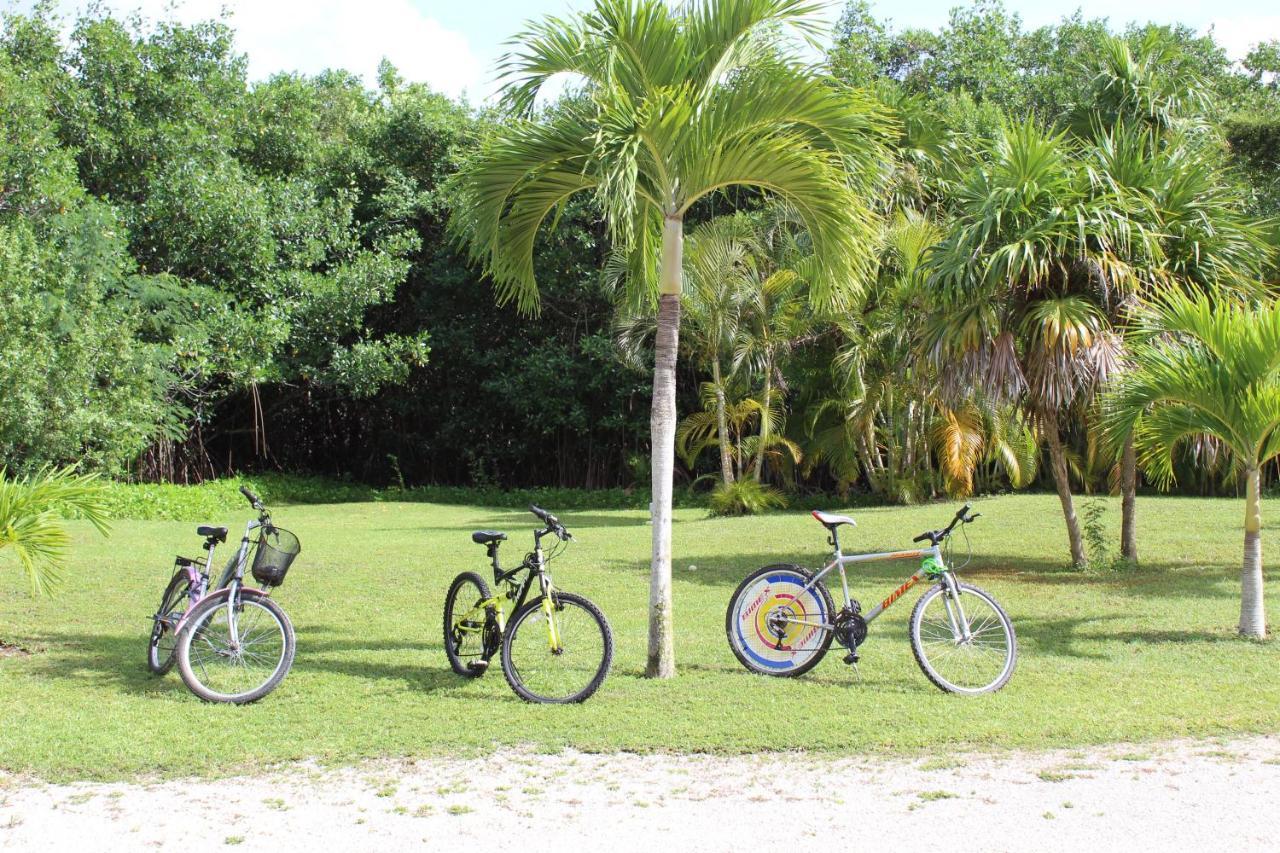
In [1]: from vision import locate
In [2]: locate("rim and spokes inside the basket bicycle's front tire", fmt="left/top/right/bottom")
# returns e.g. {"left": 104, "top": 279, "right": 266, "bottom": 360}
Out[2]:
{"left": 187, "top": 598, "right": 288, "bottom": 701}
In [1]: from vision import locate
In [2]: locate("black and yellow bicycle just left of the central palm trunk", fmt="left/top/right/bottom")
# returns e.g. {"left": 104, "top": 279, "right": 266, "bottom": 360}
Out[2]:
{"left": 444, "top": 505, "right": 613, "bottom": 704}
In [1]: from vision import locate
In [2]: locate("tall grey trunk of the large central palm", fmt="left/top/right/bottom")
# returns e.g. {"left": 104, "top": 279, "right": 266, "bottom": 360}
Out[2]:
{"left": 645, "top": 215, "right": 684, "bottom": 679}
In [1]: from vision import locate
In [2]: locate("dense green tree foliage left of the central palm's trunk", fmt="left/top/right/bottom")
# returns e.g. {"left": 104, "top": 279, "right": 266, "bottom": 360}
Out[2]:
{"left": 0, "top": 13, "right": 640, "bottom": 485}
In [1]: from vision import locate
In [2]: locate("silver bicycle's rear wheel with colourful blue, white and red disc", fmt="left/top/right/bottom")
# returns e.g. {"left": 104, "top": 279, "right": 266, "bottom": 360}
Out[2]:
{"left": 724, "top": 565, "right": 835, "bottom": 678}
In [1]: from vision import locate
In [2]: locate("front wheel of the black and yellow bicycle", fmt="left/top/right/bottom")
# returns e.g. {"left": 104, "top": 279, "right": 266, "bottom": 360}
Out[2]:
{"left": 502, "top": 592, "right": 613, "bottom": 704}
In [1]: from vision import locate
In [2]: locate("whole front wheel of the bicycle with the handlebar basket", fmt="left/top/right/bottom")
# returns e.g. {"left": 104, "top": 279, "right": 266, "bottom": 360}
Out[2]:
{"left": 178, "top": 589, "right": 294, "bottom": 704}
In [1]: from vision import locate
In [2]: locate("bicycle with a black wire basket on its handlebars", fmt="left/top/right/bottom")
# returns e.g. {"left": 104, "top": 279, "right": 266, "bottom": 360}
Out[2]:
{"left": 147, "top": 487, "right": 302, "bottom": 704}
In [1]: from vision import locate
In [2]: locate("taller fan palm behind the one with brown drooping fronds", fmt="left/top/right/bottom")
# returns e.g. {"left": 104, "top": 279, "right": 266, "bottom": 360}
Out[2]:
{"left": 1068, "top": 32, "right": 1261, "bottom": 562}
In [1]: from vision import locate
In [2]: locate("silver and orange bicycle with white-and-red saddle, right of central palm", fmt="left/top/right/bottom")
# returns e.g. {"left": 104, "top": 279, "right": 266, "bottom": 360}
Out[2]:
{"left": 724, "top": 503, "right": 1018, "bottom": 694}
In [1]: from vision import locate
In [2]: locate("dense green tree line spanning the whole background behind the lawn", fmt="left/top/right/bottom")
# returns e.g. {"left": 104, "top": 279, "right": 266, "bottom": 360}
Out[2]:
{"left": 0, "top": 0, "right": 1280, "bottom": 512}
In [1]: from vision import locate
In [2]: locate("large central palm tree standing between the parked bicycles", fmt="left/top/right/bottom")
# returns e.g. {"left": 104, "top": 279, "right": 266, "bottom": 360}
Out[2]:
{"left": 452, "top": 0, "right": 890, "bottom": 678}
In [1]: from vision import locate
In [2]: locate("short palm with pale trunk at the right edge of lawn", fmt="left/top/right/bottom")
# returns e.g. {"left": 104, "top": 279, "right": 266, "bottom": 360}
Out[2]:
{"left": 1103, "top": 291, "right": 1280, "bottom": 637}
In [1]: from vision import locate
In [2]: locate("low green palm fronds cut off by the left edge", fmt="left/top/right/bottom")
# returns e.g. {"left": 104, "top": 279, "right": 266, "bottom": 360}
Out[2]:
{"left": 0, "top": 467, "right": 108, "bottom": 594}
